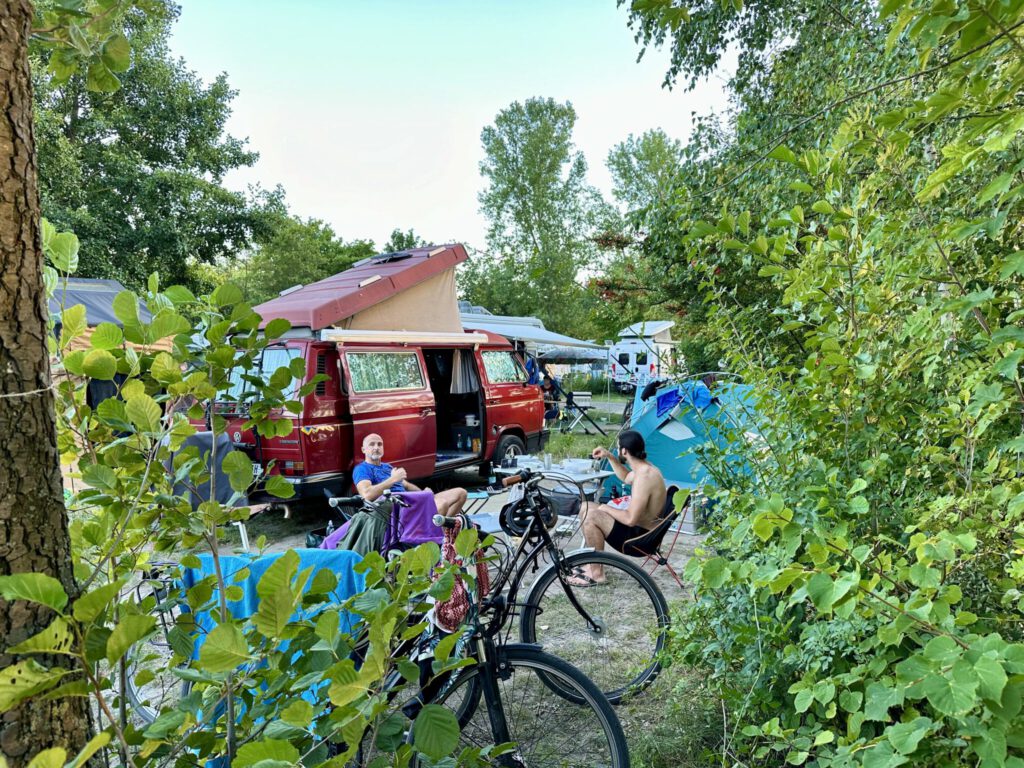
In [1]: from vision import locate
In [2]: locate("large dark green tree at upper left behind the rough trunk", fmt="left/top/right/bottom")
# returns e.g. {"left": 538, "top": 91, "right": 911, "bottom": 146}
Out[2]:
{"left": 36, "top": 0, "right": 265, "bottom": 287}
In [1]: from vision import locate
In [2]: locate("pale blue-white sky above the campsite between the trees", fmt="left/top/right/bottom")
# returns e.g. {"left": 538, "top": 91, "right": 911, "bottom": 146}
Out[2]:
{"left": 171, "top": 0, "right": 726, "bottom": 248}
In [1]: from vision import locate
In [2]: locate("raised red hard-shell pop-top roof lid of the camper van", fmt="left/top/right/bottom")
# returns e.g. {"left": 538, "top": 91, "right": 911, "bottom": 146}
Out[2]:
{"left": 255, "top": 243, "right": 469, "bottom": 331}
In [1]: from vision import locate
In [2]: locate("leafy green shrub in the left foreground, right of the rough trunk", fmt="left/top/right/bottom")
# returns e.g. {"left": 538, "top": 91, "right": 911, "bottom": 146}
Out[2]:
{"left": 0, "top": 222, "right": 487, "bottom": 768}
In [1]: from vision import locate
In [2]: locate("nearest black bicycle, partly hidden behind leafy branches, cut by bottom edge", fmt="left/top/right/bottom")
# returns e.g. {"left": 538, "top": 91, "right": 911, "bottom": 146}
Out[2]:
{"left": 128, "top": 519, "right": 630, "bottom": 768}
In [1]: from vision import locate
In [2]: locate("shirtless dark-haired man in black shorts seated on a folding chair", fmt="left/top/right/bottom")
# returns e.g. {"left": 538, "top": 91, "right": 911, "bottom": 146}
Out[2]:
{"left": 569, "top": 429, "right": 668, "bottom": 587}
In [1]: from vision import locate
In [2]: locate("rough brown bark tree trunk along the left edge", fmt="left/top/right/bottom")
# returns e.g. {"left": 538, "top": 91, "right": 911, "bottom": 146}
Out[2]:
{"left": 0, "top": 0, "right": 90, "bottom": 768}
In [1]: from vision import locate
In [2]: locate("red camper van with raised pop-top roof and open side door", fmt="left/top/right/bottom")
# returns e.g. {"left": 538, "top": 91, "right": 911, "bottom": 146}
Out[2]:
{"left": 210, "top": 245, "right": 548, "bottom": 498}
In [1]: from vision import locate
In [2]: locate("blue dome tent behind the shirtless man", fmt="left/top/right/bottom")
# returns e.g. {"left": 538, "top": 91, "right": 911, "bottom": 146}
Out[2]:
{"left": 604, "top": 378, "right": 759, "bottom": 496}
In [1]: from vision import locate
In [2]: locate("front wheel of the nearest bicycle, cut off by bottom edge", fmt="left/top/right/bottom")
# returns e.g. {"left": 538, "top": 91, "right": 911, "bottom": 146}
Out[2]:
{"left": 419, "top": 644, "right": 630, "bottom": 768}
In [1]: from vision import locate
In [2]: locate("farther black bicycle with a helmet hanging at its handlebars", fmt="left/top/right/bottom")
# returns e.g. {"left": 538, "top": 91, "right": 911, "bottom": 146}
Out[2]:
{"left": 468, "top": 469, "right": 670, "bottom": 703}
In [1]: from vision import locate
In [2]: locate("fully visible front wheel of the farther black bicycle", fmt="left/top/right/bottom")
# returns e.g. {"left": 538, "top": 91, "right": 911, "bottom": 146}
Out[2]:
{"left": 519, "top": 550, "right": 669, "bottom": 703}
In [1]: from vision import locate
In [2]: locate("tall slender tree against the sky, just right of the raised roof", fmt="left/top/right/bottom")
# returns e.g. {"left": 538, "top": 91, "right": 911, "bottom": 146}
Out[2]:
{"left": 462, "top": 98, "right": 602, "bottom": 333}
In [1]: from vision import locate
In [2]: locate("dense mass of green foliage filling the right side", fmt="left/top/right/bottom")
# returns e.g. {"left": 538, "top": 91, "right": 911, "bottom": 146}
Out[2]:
{"left": 633, "top": 1, "right": 1024, "bottom": 766}
